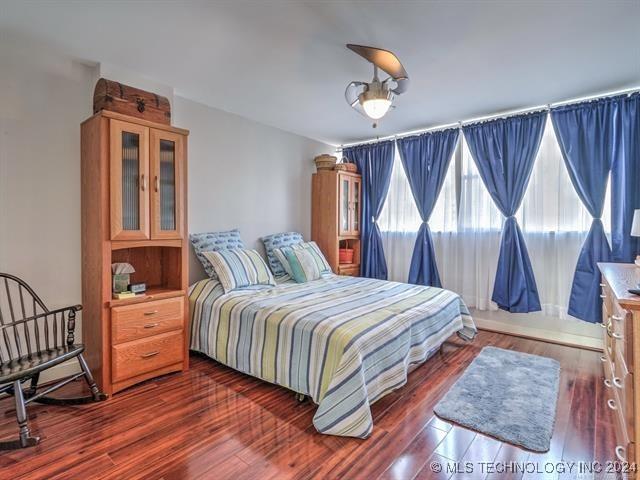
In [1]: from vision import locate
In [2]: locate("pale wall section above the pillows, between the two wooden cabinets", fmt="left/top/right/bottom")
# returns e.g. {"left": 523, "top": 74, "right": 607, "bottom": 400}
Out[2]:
{"left": 173, "top": 96, "right": 332, "bottom": 282}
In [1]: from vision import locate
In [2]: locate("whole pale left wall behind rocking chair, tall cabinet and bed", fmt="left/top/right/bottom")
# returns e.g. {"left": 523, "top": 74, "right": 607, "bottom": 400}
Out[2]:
{"left": 0, "top": 37, "right": 329, "bottom": 381}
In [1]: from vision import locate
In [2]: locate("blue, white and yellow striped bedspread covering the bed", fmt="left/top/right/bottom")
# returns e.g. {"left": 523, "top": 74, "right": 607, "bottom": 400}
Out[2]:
{"left": 190, "top": 275, "right": 476, "bottom": 438}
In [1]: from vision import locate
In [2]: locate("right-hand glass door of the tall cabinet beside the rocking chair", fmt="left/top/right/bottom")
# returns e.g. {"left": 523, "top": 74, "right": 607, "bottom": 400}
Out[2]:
{"left": 151, "top": 129, "right": 184, "bottom": 239}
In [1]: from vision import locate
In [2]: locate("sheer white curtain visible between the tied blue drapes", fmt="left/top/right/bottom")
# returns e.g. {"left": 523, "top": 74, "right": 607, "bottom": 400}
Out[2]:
{"left": 380, "top": 116, "right": 610, "bottom": 318}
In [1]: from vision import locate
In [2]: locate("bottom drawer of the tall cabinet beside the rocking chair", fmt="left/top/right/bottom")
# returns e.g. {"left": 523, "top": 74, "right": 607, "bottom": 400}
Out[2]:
{"left": 111, "top": 331, "right": 184, "bottom": 382}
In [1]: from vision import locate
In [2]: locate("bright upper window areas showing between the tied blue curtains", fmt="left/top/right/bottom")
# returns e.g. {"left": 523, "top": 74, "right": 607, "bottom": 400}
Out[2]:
{"left": 379, "top": 119, "right": 611, "bottom": 233}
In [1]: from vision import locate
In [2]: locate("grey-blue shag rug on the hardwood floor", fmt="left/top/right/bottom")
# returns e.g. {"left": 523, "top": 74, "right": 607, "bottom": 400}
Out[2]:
{"left": 434, "top": 347, "right": 560, "bottom": 452}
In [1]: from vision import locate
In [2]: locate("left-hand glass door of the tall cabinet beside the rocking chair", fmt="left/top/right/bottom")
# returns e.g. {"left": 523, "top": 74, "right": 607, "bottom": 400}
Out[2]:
{"left": 110, "top": 120, "right": 149, "bottom": 240}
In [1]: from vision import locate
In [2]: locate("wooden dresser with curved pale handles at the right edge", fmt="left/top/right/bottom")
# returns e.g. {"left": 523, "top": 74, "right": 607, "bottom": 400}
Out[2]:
{"left": 599, "top": 263, "right": 640, "bottom": 463}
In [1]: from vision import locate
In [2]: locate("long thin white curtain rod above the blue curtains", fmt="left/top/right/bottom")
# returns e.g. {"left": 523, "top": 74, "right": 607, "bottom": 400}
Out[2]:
{"left": 336, "top": 86, "right": 640, "bottom": 152}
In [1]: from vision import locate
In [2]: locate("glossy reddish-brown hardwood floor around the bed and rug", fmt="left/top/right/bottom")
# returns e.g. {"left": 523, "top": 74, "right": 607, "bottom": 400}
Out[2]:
{"left": 0, "top": 332, "right": 615, "bottom": 480}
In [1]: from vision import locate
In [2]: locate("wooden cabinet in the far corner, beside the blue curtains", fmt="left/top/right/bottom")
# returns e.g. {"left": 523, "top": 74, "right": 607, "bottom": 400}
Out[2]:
{"left": 311, "top": 170, "right": 362, "bottom": 277}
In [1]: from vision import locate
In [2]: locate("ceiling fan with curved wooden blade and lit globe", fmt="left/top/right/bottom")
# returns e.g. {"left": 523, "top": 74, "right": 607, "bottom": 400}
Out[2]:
{"left": 344, "top": 43, "right": 409, "bottom": 128}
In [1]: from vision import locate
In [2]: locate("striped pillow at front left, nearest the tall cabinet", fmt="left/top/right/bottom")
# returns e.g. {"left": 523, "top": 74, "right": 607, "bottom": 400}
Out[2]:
{"left": 204, "top": 248, "right": 276, "bottom": 293}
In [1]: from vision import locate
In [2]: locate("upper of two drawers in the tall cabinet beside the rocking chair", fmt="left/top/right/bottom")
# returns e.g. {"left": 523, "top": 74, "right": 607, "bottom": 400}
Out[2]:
{"left": 111, "top": 297, "right": 184, "bottom": 345}
